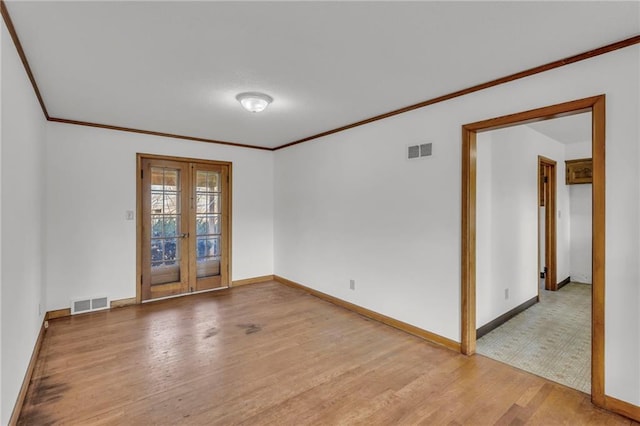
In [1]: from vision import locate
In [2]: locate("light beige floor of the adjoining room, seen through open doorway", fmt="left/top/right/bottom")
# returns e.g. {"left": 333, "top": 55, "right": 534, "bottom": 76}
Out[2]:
{"left": 477, "top": 283, "right": 591, "bottom": 393}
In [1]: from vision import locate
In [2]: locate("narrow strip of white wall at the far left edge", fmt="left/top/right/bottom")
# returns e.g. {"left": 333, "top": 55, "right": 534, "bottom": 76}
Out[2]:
{"left": 0, "top": 21, "right": 46, "bottom": 424}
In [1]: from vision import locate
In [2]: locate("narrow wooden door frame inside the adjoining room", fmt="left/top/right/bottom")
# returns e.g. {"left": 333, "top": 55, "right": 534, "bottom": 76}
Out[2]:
{"left": 536, "top": 155, "right": 558, "bottom": 291}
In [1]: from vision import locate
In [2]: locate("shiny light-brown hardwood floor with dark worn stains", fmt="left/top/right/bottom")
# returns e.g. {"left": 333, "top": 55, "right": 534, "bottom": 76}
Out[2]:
{"left": 19, "top": 282, "right": 637, "bottom": 425}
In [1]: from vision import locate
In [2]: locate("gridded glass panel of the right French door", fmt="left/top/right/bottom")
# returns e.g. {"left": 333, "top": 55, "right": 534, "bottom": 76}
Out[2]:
{"left": 195, "top": 170, "right": 222, "bottom": 278}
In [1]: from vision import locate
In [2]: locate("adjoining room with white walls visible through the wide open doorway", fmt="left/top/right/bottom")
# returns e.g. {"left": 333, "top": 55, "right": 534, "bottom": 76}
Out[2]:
{"left": 477, "top": 113, "right": 592, "bottom": 393}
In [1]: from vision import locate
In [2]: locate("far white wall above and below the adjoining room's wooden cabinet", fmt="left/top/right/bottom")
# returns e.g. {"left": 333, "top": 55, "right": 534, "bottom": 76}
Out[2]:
{"left": 566, "top": 141, "right": 593, "bottom": 284}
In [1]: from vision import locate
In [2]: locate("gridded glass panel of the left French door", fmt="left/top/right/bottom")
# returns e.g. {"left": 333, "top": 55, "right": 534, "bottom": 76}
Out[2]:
{"left": 151, "top": 167, "right": 183, "bottom": 285}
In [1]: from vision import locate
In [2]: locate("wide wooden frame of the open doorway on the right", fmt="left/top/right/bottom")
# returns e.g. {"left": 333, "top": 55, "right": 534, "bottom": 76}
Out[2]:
{"left": 460, "top": 95, "right": 606, "bottom": 407}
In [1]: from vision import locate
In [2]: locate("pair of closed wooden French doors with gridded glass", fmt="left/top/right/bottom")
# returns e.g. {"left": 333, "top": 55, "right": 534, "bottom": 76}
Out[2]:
{"left": 139, "top": 155, "right": 231, "bottom": 301}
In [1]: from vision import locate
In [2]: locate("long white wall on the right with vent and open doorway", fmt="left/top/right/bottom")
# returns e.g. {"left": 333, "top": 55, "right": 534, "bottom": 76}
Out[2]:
{"left": 275, "top": 45, "right": 640, "bottom": 405}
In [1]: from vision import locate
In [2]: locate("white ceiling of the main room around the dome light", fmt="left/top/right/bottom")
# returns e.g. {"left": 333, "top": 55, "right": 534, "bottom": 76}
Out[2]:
{"left": 6, "top": 0, "right": 640, "bottom": 147}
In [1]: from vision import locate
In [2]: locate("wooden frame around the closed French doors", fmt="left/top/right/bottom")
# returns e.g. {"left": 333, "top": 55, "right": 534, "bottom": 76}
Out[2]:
{"left": 135, "top": 153, "right": 233, "bottom": 304}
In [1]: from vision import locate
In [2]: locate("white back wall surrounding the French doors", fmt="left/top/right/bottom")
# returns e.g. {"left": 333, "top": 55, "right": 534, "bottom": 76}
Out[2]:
{"left": 46, "top": 123, "right": 273, "bottom": 310}
